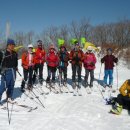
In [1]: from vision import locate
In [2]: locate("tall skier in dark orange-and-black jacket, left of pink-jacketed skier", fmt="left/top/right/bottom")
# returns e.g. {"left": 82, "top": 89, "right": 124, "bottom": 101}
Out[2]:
{"left": 69, "top": 42, "right": 84, "bottom": 95}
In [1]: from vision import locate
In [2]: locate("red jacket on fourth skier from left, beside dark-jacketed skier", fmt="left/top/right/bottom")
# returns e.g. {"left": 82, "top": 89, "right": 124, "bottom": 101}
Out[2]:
{"left": 46, "top": 51, "right": 59, "bottom": 67}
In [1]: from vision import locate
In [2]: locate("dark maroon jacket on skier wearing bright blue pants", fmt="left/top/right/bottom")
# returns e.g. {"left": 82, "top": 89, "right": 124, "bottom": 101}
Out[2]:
{"left": 101, "top": 55, "right": 118, "bottom": 69}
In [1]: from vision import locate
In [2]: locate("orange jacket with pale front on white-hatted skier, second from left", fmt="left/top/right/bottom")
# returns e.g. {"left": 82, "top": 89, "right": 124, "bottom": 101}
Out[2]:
{"left": 22, "top": 52, "right": 35, "bottom": 69}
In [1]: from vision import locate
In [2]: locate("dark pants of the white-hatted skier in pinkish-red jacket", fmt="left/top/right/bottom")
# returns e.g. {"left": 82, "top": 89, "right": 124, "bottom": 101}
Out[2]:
{"left": 84, "top": 69, "right": 94, "bottom": 87}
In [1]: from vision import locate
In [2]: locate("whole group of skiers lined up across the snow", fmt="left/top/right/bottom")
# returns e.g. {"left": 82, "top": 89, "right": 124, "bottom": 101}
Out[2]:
{"left": 0, "top": 39, "right": 130, "bottom": 115}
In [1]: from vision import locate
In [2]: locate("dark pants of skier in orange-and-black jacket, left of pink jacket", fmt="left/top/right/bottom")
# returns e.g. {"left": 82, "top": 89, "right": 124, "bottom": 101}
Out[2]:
{"left": 72, "top": 64, "right": 81, "bottom": 82}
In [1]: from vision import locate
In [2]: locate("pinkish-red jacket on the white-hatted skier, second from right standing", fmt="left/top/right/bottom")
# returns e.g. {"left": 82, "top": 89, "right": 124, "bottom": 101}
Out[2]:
{"left": 84, "top": 53, "right": 96, "bottom": 70}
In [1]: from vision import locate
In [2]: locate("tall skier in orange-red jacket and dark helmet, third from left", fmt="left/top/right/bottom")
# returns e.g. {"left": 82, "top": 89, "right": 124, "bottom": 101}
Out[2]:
{"left": 33, "top": 40, "right": 46, "bottom": 84}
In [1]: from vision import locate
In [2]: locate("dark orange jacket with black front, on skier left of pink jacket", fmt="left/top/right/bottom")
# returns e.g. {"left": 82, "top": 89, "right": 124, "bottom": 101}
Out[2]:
{"left": 69, "top": 49, "right": 84, "bottom": 66}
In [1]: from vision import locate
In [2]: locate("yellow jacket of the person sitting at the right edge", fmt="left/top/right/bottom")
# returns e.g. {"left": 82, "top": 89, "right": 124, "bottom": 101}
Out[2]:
{"left": 119, "top": 80, "right": 130, "bottom": 97}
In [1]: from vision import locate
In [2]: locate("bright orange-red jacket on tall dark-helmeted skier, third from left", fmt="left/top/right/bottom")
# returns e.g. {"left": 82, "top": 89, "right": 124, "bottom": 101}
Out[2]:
{"left": 35, "top": 48, "right": 46, "bottom": 64}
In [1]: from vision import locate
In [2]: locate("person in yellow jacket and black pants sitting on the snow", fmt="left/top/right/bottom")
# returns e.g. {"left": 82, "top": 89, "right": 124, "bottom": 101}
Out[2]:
{"left": 110, "top": 79, "right": 130, "bottom": 115}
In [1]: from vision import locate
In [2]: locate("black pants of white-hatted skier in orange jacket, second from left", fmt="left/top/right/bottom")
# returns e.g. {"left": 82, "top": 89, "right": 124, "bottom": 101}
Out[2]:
{"left": 21, "top": 67, "right": 33, "bottom": 88}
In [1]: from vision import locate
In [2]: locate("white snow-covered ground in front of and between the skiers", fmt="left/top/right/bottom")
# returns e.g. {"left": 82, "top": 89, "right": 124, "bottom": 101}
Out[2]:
{"left": 0, "top": 57, "right": 130, "bottom": 130}
